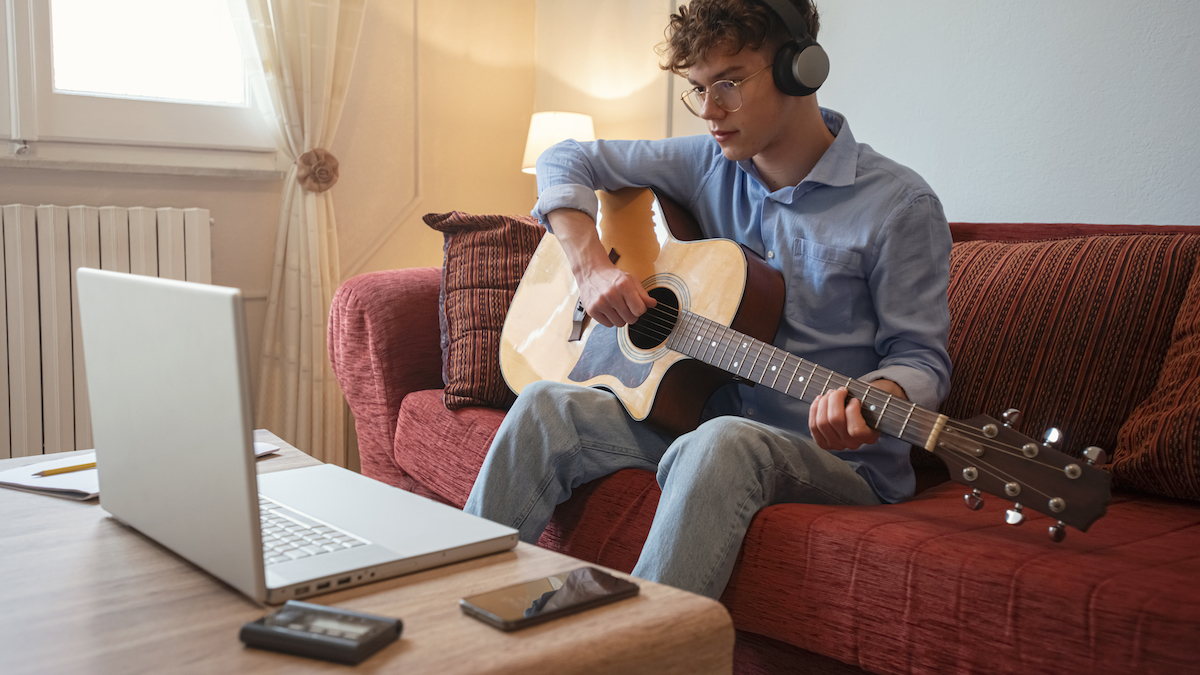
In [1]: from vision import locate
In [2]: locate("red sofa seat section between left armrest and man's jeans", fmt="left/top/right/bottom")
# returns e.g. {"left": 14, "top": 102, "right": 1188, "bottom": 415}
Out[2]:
{"left": 395, "top": 389, "right": 504, "bottom": 508}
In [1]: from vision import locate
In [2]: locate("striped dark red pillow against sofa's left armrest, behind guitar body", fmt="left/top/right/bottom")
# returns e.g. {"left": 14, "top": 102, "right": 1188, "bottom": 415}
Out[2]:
{"left": 424, "top": 211, "right": 546, "bottom": 410}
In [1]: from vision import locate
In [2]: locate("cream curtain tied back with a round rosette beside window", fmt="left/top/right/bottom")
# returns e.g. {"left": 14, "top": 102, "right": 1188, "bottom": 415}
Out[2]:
{"left": 237, "top": 0, "right": 366, "bottom": 464}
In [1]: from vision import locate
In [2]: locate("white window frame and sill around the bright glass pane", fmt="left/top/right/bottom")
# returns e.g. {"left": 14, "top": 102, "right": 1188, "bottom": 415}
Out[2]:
{"left": 0, "top": 0, "right": 287, "bottom": 179}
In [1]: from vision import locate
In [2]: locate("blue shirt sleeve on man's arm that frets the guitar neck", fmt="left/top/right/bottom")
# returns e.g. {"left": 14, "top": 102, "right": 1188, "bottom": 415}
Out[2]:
{"left": 863, "top": 193, "right": 952, "bottom": 408}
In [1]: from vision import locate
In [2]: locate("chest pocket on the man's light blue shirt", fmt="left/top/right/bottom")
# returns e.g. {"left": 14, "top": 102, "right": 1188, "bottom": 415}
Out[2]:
{"left": 785, "top": 239, "right": 869, "bottom": 328}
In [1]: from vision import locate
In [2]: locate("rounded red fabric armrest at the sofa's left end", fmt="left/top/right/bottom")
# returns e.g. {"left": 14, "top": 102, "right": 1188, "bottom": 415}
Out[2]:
{"left": 329, "top": 268, "right": 444, "bottom": 485}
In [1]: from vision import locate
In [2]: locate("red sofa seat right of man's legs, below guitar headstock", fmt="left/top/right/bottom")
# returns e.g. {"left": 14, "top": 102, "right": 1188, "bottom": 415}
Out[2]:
{"left": 721, "top": 484, "right": 1200, "bottom": 674}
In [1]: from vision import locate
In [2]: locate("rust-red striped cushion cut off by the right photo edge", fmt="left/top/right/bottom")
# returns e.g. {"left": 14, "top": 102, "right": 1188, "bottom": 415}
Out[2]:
{"left": 1111, "top": 263, "right": 1200, "bottom": 500}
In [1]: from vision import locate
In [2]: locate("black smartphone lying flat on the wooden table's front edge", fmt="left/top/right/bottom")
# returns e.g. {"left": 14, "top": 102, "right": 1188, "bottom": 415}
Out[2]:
{"left": 458, "top": 567, "right": 637, "bottom": 631}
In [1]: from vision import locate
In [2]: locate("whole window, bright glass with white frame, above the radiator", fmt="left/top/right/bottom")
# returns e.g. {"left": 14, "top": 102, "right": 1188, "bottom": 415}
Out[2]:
{"left": 0, "top": 0, "right": 278, "bottom": 177}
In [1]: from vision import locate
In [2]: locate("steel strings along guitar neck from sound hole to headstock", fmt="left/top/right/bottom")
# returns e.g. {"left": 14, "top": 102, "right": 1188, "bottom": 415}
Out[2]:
{"left": 630, "top": 306, "right": 1075, "bottom": 471}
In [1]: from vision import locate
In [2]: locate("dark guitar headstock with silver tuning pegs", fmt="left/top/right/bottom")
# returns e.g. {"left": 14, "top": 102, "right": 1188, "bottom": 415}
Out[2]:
{"left": 934, "top": 411, "right": 1112, "bottom": 540}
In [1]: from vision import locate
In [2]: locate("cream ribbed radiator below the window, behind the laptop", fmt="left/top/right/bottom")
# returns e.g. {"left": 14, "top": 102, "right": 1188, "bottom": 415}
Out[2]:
{"left": 0, "top": 204, "right": 212, "bottom": 458}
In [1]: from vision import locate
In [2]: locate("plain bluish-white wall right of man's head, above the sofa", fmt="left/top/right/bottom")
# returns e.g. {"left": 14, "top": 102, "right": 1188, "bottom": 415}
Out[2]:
{"left": 817, "top": 0, "right": 1200, "bottom": 225}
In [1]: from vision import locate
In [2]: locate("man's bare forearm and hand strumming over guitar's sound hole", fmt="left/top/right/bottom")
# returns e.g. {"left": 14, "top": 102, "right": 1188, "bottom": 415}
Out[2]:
{"left": 547, "top": 209, "right": 658, "bottom": 327}
